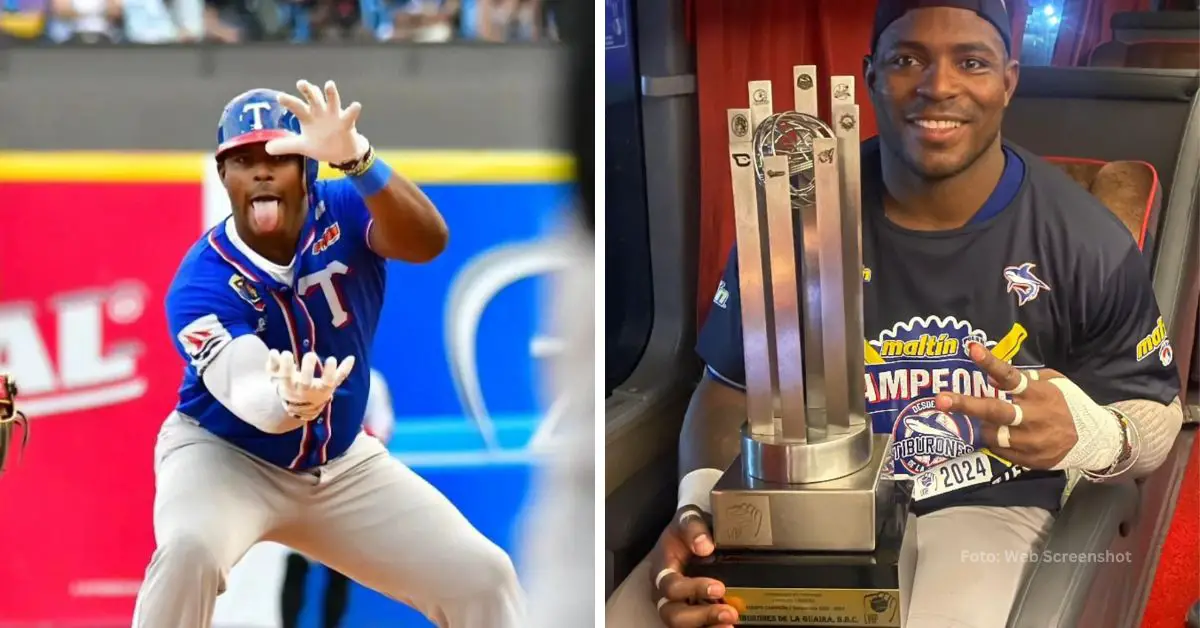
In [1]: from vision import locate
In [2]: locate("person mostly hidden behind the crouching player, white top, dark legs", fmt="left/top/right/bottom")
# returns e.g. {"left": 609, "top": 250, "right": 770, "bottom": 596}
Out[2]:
{"left": 280, "top": 369, "right": 396, "bottom": 628}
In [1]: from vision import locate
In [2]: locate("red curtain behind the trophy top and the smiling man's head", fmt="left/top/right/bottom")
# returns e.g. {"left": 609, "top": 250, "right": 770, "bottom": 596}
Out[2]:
{"left": 686, "top": 0, "right": 1027, "bottom": 324}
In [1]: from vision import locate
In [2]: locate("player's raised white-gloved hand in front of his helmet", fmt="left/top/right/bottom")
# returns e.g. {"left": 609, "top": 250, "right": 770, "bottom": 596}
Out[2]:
{"left": 265, "top": 80, "right": 371, "bottom": 163}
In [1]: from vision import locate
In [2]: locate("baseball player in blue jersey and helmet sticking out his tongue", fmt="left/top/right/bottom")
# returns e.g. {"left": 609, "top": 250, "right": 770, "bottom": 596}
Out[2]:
{"left": 133, "top": 80, "right": 524, "bottom": 628}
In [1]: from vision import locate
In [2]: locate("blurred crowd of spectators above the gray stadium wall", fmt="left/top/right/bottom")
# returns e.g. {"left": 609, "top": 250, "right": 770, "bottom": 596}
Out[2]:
{"left": 0, "top": 0, "right": 569, "bottom": 44}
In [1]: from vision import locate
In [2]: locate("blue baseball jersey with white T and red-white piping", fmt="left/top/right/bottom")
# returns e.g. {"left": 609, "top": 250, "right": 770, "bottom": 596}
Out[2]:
{"left": 167, "top": 179, "right": 385, "bottom": 469}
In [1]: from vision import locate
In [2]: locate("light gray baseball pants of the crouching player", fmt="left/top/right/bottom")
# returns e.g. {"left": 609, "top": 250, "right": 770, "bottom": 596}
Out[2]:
{"left": 133, "top": 413, "right": 524, "bottom": 628}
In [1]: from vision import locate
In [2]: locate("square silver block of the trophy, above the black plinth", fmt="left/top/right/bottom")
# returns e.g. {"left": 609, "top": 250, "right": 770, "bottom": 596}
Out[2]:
{"left": 712, "top": 435, "right": 896, "bottom": 551}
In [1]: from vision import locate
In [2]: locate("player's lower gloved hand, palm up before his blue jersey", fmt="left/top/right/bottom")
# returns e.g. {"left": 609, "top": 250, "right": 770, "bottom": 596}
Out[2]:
{"left": 266, "top": 349, "right": 354, "bottom": 420}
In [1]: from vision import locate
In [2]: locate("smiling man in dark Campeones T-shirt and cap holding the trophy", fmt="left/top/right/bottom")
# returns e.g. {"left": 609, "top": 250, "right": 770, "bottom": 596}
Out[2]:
{"left": 607, "top": 0, "right": 1183, "bottom": 628}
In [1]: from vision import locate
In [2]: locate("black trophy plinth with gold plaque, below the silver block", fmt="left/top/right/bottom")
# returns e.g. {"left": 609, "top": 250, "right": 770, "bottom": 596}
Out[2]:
{"left": 686, "top": 503, "right": 916, "bottom": 628}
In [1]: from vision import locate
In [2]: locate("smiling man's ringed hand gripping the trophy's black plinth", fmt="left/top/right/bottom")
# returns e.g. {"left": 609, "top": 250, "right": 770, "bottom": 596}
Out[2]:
{"left": 650, "top": 506, "right": 738, "bottom": 628}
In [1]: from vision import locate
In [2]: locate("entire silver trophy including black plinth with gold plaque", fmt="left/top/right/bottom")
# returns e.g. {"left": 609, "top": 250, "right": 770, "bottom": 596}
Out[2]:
{"left": 688, "top": 66, "right": 907, "bottom": 627}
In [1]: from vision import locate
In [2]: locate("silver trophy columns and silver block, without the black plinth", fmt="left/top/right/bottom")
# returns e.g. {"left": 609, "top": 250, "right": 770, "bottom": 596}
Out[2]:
{"left": 712, "top": 66, "right": 892, "bottom": 552}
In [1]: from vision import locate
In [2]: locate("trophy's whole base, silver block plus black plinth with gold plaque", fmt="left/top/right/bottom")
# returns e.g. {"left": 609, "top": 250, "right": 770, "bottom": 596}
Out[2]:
{"left": 686, "top": 435, "right": 914, "bottom": 628}
